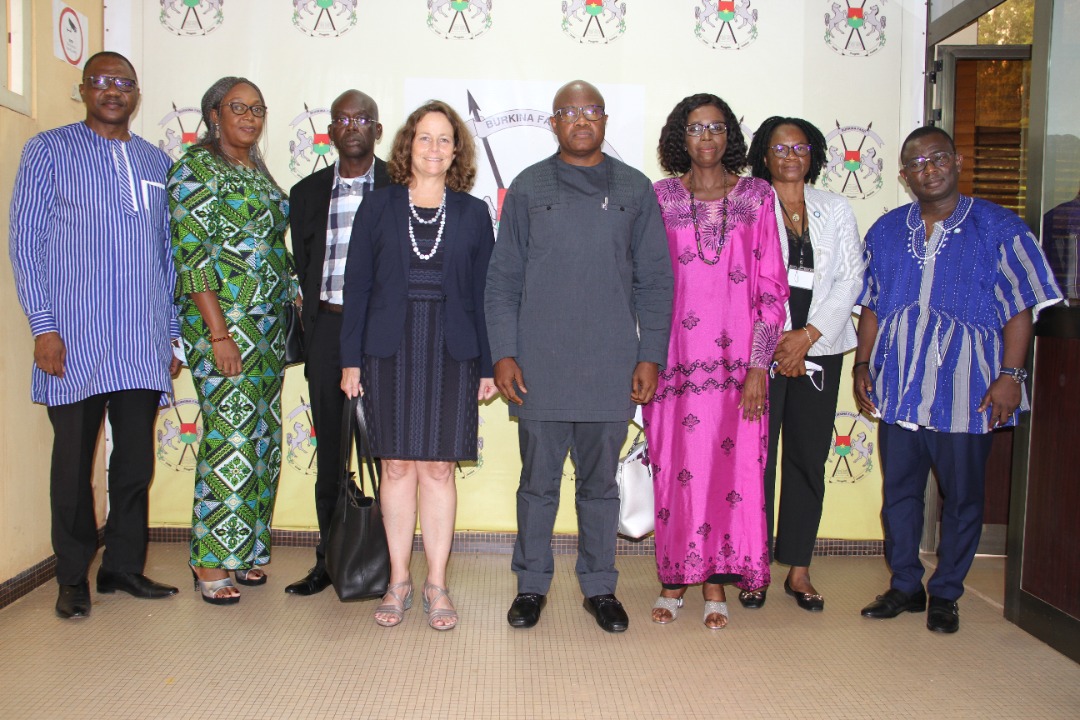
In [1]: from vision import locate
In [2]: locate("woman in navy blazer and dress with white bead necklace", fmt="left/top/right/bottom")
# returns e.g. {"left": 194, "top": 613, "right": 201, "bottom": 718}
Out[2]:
{"left": 341, "top": 100, "right": 496, "bottom": 630}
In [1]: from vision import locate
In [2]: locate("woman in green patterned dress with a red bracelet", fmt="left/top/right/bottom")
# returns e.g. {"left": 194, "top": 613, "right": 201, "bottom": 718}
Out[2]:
{"left": 168, "top": 78, "right": 297, "bottom": 604}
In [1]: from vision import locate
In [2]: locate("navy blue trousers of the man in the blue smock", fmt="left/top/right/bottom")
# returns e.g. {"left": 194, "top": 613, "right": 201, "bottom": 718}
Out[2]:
{"left": 878, "top": 423, "right": 993, "bottom": 600}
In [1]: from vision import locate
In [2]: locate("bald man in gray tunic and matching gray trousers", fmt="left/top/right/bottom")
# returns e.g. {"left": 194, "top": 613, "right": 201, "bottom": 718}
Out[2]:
{"left": 485, "top": 81, "right": 673, "bottom": 633}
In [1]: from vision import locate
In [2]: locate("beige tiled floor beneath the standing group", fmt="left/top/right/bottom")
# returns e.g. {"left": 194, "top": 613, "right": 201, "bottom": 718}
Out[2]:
{"left": 0, "top": 543, "right": 1080, "bottom": 720}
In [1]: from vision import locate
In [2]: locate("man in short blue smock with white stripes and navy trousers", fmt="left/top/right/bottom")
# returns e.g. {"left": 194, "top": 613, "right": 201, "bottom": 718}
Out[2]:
{"left": 854, "top": 127, "right": 1062, "bottom": 633}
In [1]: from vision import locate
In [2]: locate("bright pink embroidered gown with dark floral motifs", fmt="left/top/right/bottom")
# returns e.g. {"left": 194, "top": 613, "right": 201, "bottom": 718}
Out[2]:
{"left": 644, "top": 178, "right": 788, "bottom": 589}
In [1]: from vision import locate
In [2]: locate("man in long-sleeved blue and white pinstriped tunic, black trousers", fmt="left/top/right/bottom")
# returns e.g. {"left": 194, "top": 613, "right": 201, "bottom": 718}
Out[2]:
{"left": 10, "top": 52, "right": 179, "bottom": 617}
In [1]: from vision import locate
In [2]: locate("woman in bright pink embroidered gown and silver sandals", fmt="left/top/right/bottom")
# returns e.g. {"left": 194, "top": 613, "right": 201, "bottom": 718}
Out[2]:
{"left": 644, "top": 94, "right": 788, "bottom": 629}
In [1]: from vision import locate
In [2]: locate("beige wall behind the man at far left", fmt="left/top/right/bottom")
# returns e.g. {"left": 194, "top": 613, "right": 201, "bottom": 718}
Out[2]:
{"left": 0, "top": 0, "right": 103, "bottom": 582}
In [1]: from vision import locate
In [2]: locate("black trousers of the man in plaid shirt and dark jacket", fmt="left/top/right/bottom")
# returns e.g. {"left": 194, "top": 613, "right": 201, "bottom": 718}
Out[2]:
{"left": 305, "top": 311, "right": 367, "bottom": 568}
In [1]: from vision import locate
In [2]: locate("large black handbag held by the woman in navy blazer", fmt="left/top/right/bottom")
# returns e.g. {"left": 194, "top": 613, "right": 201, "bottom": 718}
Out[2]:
{"left": 326, "top": 397, "right": 390, "bottom": 602}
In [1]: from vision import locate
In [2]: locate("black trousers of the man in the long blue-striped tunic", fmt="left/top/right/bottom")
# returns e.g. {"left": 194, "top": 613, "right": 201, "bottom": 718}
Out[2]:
{"left": 49, "top": 390, "right": 161, "bottom": 585}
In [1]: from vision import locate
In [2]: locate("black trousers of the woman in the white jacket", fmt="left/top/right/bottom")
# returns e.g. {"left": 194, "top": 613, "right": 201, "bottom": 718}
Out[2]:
{"left": 765, "top": 355, "right": 843, "bottom": 567}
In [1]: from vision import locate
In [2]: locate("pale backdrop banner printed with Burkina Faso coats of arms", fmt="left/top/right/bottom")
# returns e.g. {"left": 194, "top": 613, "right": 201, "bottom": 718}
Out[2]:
{"left": 106, "top": 0, "right": 927, "bottom": 539}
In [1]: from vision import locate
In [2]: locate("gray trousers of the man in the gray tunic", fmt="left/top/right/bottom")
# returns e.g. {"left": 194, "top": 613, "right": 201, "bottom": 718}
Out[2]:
{"left": 511, "top": 419, "right": 626, "bottom": 597}
